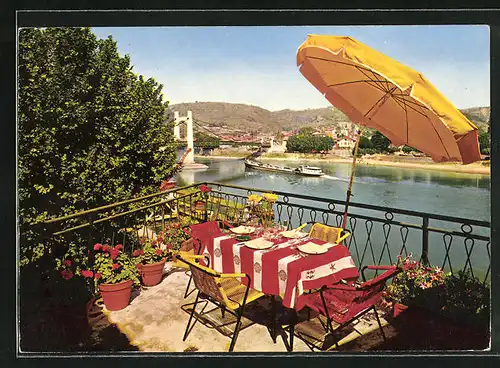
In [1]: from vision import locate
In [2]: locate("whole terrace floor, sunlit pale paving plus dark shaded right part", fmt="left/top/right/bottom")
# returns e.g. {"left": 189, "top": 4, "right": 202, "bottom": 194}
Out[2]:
{"left": 85, "top": 263, "right": 489, "bottom": 353}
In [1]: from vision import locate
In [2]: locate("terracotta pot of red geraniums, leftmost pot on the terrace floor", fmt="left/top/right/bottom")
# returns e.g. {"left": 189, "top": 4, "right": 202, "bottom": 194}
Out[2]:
{"left": 80, "top": 243, "right": 139, "bottom": 311}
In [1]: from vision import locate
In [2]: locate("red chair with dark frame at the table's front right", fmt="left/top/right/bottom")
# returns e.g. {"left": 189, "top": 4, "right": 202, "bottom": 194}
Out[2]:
{"left": 290, "top": 266, "right": 398, "bottom": 349}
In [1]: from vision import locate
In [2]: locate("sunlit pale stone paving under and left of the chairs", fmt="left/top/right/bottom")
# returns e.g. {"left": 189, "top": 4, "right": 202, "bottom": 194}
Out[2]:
{"left": 97, "top": 263, "right": 387, "bottom": 353}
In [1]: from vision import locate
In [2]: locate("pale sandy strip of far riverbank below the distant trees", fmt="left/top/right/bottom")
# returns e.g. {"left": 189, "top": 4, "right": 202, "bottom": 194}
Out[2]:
{"left": 198, "top": 153, "right": 490, "bottom": 175}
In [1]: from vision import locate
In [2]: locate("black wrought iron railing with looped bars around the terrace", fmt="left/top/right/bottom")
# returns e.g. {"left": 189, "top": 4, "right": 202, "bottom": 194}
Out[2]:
{"left": 37, "top": 183, "right": 491, "bottom": 282}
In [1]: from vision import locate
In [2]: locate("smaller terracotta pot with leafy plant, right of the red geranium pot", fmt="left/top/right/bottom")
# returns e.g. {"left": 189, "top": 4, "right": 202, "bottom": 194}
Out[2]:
{"left": 132, "top": 236, "right": 172, "bottom": 286}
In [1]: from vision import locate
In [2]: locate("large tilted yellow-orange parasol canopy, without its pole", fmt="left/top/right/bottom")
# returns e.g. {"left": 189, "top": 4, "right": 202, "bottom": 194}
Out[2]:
{"left": 297, "top": 35, "right": 481, "bottom": 164}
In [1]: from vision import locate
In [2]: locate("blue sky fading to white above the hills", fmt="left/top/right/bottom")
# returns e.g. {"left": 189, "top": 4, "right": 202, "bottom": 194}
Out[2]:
{"left": 93, "top": 25, "right": 490, "bottom": 110}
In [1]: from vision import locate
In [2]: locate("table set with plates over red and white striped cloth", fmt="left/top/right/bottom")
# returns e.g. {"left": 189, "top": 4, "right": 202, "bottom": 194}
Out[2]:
{"left": 202, "top": 224, "right": 359, "bottom": 310}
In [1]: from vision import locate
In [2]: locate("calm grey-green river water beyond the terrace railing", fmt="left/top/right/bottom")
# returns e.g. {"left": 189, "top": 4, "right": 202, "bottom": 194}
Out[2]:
{"left": 177, "top": 159, "right": 490, "bottom": 273}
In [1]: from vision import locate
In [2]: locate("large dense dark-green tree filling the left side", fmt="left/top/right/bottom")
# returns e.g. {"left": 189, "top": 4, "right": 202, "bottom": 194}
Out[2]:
{"left": 18, "top": 28, "right": 176, "bottom": 264}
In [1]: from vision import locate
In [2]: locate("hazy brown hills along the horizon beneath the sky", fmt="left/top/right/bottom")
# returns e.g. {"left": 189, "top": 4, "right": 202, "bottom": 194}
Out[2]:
{"left": 169, "top": 102, "right": 490, "bottom": 133}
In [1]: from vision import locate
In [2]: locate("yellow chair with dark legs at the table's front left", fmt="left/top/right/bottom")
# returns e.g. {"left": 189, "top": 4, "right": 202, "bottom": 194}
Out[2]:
{"left": 177, "top": 255, "right": 264, "bottom": 351}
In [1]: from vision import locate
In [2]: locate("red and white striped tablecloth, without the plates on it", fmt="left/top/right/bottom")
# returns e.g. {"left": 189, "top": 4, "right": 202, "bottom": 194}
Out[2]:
{"left": 202, "top": 235, "right": 359, "bottom": 310}
